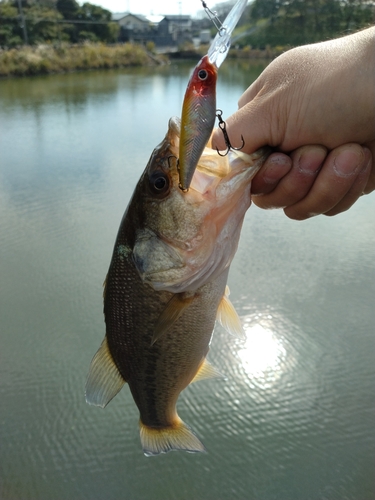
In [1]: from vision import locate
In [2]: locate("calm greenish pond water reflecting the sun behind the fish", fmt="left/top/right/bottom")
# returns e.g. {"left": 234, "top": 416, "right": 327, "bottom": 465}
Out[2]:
{"left": 0, "top": 61, "right": 375, "bottom": 500}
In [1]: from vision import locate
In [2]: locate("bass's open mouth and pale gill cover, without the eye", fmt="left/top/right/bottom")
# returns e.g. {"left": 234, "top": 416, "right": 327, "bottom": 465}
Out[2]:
{"left": 137, "top": 117, "right": 266, "bottom": 293}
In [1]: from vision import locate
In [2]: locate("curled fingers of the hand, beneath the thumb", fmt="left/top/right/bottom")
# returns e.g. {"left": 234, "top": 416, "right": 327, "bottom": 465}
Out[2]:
{"left": 251, "top": 143, "right": 375, "bottom": 220}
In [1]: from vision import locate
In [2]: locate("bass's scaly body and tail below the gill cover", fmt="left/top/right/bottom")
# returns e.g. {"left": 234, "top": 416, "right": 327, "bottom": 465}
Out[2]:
{"left": 105, "top": 244, "right": 228, "bottom": 455}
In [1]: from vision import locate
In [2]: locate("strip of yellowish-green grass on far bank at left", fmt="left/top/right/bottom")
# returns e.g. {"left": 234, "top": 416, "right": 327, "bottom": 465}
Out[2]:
{"left": 0, "top": 43, "right": 163, "bottom": 76}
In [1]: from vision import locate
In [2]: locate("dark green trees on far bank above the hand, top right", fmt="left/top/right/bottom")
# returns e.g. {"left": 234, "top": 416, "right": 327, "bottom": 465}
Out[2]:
{"left": 245, "top": 0, "right": 375, "bottom": 48}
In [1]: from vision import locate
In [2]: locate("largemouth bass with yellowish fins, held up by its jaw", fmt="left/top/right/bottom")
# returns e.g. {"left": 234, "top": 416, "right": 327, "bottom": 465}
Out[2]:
{"left": 86, "top": 118, "right": 268, "bottom": 456}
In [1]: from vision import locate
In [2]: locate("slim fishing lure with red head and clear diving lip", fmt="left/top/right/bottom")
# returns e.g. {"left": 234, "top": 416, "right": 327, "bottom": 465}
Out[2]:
{"left": 179, "top": 0, "right": 247, "bottom": 191}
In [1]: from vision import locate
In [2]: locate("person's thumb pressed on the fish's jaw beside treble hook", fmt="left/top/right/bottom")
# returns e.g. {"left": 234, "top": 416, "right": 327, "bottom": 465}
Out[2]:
{"left": 212, "top": 97, "right": 277, "bottom": 154}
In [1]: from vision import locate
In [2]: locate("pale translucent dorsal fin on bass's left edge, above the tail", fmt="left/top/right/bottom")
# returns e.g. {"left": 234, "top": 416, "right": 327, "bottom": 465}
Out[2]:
{"left": 86, "top": 337, "right": 125, "bottom": 408}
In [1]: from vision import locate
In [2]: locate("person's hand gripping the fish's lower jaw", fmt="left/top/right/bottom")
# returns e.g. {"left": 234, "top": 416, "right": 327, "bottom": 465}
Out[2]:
{"left": 213, "top": 27, "right": 375, "bottom": 220}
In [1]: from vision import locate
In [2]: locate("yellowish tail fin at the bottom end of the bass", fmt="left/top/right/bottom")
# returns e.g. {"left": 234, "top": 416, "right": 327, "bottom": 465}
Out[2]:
{"left": 139, "top": 417, "right": 206, "bottom": 457}
